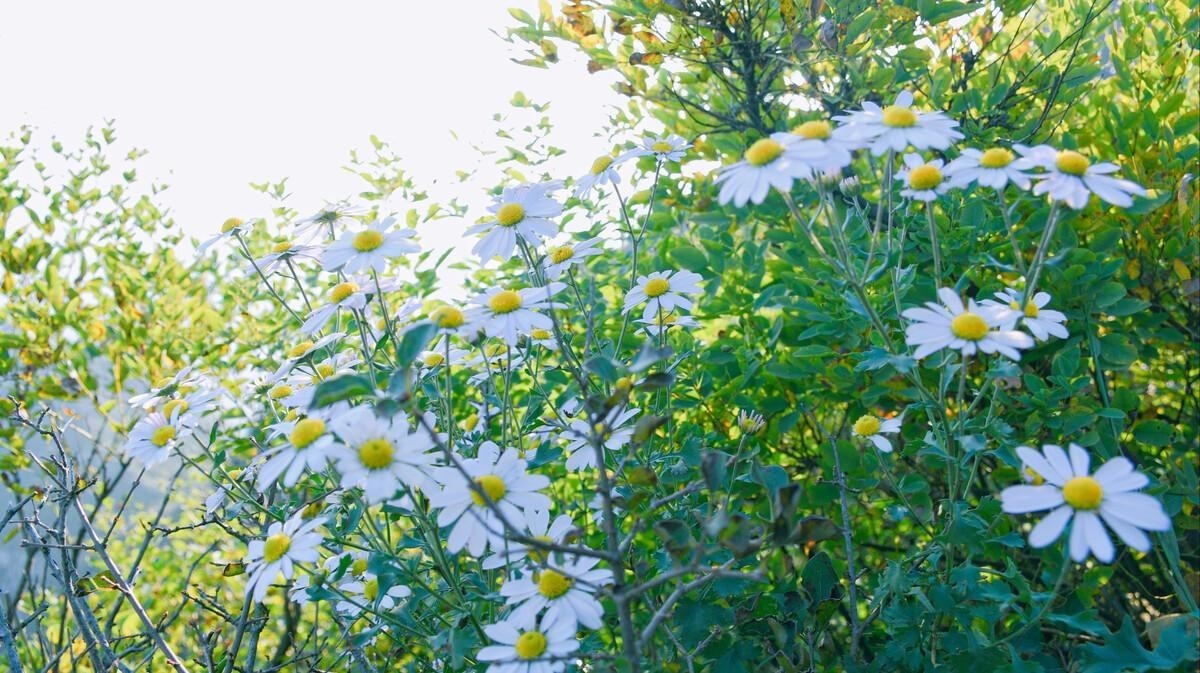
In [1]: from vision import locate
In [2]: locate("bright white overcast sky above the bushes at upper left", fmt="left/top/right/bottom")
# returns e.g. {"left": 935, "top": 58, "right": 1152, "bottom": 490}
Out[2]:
{"left": 0, "top": 0, "right": 622, "bottom": 254}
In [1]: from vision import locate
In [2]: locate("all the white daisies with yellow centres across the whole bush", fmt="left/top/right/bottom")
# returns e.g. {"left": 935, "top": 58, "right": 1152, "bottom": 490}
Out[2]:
{"left": 114, "top": 86, "right": 1169, "bottom": 673}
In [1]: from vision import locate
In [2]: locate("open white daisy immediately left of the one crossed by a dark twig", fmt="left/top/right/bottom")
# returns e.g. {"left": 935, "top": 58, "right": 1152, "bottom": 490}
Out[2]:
{"left": 329, "top": 404, "right": 437, "bottom": 503}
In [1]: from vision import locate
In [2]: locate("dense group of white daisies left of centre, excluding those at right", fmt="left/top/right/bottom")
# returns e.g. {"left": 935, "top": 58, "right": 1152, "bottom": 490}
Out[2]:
{"left": 130, "top": 137, "right": 702, "bottom": 673}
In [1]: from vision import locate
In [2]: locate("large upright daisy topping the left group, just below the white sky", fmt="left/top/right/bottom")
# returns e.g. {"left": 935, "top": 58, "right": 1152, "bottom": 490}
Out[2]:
{"left": 466, "top": 182, "right": 563, "bottom": 263}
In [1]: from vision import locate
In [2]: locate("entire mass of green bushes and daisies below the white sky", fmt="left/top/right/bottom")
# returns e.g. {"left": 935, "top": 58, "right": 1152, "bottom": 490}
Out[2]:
{"left": 0, "top": 0, "right": 1200, "bottom": 673}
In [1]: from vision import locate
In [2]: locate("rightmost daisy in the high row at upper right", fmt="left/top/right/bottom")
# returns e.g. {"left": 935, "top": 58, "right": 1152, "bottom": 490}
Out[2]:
{"left": 1013, "top": 145, "right": 1146, "bottom": 210}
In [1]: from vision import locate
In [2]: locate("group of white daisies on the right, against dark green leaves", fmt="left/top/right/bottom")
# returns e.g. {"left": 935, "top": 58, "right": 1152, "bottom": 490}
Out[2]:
{"left": 716, "top": 91, "right": 1170, "bottom": 563}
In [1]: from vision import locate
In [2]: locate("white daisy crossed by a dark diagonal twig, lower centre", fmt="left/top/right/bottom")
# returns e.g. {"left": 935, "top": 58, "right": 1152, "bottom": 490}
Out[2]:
{"left": 430, "top": 441, "right": 551, "bottom": 558}
